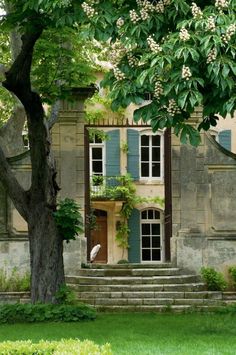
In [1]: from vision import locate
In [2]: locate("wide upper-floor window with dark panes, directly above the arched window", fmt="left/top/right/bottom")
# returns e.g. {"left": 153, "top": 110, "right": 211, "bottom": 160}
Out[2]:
{"left": 140, "top": 134, "right": 163, "bottom": 179}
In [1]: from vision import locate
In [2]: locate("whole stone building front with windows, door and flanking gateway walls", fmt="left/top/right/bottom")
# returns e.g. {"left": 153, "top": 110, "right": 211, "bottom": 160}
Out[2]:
{"left": 0, "top": 90, "right": 236, "bottom": 274}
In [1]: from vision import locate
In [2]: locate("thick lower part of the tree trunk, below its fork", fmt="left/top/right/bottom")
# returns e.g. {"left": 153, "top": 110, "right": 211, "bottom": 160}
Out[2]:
{"left": 28, "top": 204, "right": 65, "bottom": 303}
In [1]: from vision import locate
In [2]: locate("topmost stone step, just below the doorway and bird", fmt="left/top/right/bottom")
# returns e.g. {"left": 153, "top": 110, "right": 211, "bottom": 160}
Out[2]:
{"left": 85, "top": 263, "right": 173, "bottom": 269}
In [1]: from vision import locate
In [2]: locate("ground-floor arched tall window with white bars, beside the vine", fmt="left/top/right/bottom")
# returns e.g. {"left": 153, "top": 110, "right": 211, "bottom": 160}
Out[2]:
{"left": 141, "top": 209, "right": 162, "bottom": 261}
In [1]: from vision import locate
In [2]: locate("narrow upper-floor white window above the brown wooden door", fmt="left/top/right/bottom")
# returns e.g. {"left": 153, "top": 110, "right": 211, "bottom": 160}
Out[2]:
{"left": 89, "top": 136, "right": 105, "bottom": 176}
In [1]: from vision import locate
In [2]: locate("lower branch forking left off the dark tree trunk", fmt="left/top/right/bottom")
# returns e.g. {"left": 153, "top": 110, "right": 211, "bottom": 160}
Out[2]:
{"left": 0, "top": 146, "right": 28, "bottom": 221}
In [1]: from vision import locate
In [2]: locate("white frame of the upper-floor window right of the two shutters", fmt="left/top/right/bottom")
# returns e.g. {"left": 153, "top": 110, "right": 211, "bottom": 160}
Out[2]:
{"left": 139, "top": 130, "right": 164, "bottom": 181}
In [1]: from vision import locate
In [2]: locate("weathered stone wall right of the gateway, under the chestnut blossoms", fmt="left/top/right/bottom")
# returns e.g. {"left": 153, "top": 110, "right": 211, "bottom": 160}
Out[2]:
{"left": 171, "top": 118, "right": 236, "bottom": 273}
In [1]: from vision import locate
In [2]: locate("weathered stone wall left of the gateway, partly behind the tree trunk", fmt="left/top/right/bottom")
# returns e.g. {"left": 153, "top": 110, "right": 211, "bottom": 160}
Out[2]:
{"left": 0, "top": 90, "right": 89, "bottom": 274}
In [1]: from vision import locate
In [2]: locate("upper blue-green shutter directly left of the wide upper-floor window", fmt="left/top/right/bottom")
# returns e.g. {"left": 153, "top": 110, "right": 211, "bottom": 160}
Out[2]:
{"left": 127, "top": 129, "right": 139, "bottom": 180}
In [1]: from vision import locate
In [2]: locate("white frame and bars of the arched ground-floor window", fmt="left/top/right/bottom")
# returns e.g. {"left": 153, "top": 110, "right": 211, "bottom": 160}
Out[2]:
{"left": 140, "top": 207, "right": 165, "bottom": 264}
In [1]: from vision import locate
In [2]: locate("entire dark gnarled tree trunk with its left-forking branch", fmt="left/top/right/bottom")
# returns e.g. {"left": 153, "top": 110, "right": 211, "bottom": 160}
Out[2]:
{"left": 0, "top": 24, "right": 64, "bottom": 302}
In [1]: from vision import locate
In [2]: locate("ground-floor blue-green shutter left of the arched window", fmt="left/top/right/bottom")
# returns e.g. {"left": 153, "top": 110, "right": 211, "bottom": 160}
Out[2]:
{"left": 128, "top": 208, "right": 140, "bottom": 263}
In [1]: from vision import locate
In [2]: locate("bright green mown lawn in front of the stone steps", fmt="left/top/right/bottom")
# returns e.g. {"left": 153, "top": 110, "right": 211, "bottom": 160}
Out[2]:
{"left": 0, "top": 313, "right": 236, "bottom": 355}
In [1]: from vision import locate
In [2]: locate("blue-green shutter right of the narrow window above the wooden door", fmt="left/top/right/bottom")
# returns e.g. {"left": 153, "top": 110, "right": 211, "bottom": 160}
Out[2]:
{"left": 106, "top": 129, "right": 120, "bottom": 176}
